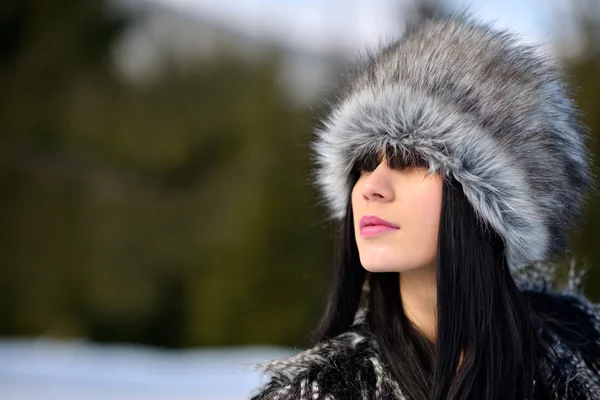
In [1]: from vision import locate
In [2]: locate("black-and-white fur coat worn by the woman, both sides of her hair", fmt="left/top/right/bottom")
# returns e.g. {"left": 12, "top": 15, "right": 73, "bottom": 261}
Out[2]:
{"left": 252, "top": 270, "right": 600, "bottom": 400}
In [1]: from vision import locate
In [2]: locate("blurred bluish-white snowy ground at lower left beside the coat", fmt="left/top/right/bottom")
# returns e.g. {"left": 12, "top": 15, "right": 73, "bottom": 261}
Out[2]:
{"left": 0, "top": 340, "right": 294, "bottom": 400}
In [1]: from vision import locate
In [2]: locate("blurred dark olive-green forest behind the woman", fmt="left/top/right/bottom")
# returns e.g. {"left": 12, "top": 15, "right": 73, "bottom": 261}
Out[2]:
{"left": 0, "top": 0, "right": 600, "bottom": 348}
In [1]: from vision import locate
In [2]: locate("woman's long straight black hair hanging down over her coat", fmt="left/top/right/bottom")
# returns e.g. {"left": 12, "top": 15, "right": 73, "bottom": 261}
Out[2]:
{"left": 315, "top": 151, "right": 542, "bottom": 400}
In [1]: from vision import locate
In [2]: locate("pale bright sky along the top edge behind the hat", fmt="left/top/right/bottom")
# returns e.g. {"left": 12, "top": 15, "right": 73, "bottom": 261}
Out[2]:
{"left": 142, "top": 0, "right": 569, "bottom": 52}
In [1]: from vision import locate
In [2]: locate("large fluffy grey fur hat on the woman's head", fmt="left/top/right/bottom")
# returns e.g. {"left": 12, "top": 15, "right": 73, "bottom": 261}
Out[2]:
{"left": 312, "top": 15, "right": 591, "bottom": 269}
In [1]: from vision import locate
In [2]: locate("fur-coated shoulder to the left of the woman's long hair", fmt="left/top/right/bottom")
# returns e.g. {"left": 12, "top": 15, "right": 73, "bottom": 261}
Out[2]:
{"left": 252, "top": 326, "right": 402, "bottom": 400}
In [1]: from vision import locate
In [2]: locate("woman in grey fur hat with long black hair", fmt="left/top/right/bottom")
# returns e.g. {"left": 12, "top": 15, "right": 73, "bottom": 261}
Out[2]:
{"left": 254, "top": 12, "right": 600, "bottom": 400}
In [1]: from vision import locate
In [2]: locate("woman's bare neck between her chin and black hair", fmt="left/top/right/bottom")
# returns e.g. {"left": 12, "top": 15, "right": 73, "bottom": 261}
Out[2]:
{"left": 399, "top": 266, "right": 437, "bottom": 343}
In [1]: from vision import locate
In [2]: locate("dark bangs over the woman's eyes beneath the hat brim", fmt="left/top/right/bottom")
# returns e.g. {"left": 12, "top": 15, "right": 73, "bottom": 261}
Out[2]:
{"left": 352, "top": 146, "right": 428, "bottom": 175}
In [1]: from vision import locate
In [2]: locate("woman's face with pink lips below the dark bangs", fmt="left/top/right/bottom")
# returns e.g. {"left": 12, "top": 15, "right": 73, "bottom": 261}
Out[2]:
{"left": 352, "top": 152, "right": 443, "bottom": 272}
